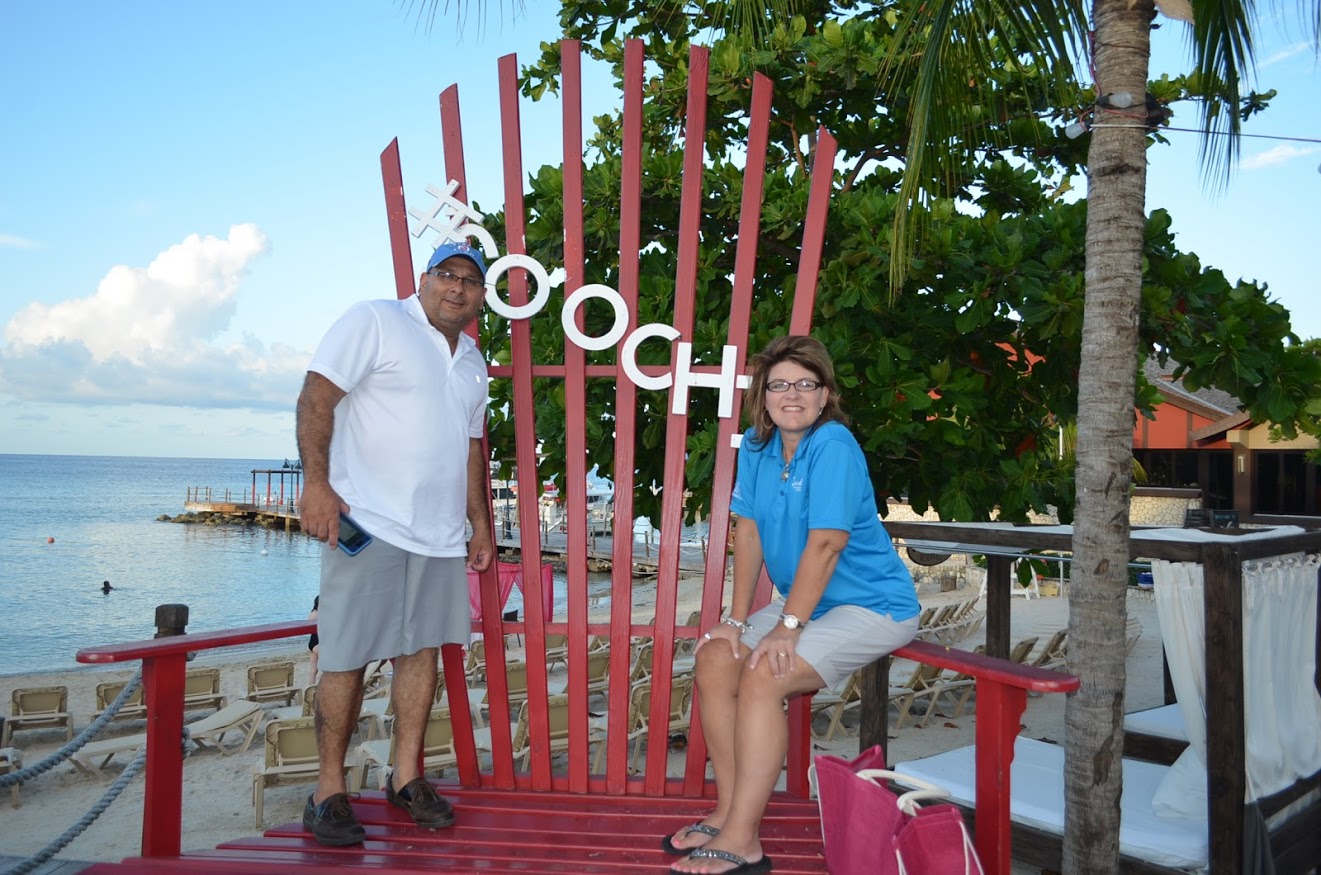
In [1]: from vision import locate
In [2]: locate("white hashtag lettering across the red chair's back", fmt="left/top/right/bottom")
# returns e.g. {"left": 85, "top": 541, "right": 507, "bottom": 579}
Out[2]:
{"left": 408, "top": 180, "right": 749, "bottom": 422}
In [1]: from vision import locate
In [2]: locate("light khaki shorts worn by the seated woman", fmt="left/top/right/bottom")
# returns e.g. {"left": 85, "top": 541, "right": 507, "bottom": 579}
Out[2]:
{"left": 740, "top": 599, "right": 918, "bottom": 686}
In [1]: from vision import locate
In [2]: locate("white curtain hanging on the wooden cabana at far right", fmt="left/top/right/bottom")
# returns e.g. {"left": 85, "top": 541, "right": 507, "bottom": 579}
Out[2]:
{"left": 1152, "top": 544, "right": 1321, "bottom": 818}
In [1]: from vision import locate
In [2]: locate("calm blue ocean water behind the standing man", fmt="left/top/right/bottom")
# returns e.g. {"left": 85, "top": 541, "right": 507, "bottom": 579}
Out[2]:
{"left": 0, "top": 455, "right": 609, "bottom": 675}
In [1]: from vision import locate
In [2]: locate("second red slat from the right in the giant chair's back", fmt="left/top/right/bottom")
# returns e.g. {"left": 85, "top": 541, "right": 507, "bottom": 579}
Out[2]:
{"left": 684, "top": 73, "right": 774, "bottom": 794}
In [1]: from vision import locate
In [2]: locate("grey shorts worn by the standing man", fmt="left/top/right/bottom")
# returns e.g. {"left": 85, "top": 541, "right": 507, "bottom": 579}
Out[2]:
{"left": 317, "top": 538, "right": 472, "bottom": 671}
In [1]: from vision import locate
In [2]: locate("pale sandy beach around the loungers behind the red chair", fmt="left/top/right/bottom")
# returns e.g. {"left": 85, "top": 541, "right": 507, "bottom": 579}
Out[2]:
{"left": 0, "top": 582, "right": 1161, "bottom": 872}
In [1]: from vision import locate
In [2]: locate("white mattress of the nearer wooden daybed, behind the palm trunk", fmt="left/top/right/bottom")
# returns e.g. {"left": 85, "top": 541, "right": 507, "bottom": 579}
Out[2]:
{"left": 892, "top": 738, "right": 1209, "bottom": 870}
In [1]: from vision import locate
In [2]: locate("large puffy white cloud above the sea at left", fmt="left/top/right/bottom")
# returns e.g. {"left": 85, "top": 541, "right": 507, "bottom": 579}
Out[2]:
{"left": 0, "top": 225, "right": 309, "bottom": 410}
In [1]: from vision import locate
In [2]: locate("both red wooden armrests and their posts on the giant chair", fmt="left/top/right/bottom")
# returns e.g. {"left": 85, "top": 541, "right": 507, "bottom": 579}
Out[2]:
{"left": 77, "top": 621, "right": 1078, "bottom": 875}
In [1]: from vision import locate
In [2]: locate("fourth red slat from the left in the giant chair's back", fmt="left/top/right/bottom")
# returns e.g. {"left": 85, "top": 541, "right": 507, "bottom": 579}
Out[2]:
{"left": 554, "top": 40, "right": 590, "bottom": 792}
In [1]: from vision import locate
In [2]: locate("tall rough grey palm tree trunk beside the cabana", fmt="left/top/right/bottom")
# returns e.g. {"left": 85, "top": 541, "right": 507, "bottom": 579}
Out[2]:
{"left": 1063, "top": 0, "right": 1153, "bottom": 875}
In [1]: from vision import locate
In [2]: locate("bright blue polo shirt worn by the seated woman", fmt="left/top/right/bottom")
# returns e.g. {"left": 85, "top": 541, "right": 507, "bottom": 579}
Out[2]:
{"left": 729, "top": 422, "right": 918, "bottom": 620}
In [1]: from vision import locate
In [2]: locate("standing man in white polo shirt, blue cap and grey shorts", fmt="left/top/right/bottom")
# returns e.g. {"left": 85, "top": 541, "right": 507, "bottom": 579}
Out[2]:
{"left": 297, "top": 242, "right": 494, "bottom": 845}
